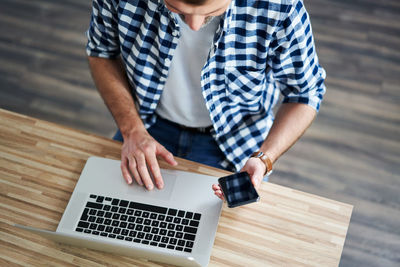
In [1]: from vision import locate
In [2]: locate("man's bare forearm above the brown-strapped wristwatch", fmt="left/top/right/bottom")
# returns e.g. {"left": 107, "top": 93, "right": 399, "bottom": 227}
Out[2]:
{"left": 260, "top": 103, "right": 316, "bottom": 163}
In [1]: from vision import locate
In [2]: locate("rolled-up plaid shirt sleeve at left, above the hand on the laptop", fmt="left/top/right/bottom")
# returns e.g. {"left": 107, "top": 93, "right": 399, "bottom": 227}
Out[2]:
{"left": 86, "top": 0, "right": 120, "bottom": 58}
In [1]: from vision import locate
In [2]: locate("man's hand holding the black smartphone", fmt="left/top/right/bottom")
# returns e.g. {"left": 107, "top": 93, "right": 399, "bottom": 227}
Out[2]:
{"left": 212, "top": 158, "right": 266, "bottom": 200}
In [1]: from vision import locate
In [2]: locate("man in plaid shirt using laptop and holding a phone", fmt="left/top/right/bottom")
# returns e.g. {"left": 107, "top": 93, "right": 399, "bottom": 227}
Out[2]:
{"left": 87, "top": 0, "right": 325, "bottom": 198}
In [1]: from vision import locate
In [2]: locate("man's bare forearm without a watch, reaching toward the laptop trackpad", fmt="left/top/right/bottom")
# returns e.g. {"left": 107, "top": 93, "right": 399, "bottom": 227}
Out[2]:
{"left": 88, "top": 57, "right": 144, "bottom": 138}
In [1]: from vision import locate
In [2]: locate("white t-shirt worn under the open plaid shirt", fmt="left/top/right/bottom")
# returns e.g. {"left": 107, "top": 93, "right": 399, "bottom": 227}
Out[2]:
{"left": 156, "top": 14, "right": 220, "bottom": 127}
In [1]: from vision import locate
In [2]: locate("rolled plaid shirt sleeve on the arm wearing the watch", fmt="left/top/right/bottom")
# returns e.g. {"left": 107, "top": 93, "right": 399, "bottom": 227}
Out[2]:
{"left": 268, "top": 0, "right": 326, "bottom": 112}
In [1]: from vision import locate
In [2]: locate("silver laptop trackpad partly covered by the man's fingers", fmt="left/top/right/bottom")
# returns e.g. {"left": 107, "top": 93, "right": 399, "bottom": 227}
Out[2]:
{"left": 125, "top": 170, "right": 176, "bottom": 200}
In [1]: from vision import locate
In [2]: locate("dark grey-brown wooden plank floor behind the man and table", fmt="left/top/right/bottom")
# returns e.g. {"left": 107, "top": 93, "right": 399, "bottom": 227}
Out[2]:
{"left": 0, "top": 0, "right": 400, "bottom": 266}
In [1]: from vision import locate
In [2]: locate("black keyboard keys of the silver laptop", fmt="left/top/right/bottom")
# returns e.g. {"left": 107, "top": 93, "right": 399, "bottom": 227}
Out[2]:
{"left": 75, "top": 195, "right": 201, "bottom": 252}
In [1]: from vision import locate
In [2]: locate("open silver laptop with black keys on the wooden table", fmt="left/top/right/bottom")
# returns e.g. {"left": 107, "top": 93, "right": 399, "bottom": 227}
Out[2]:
{"left": 16, "top": 157, "right": 222, "bottom": 266}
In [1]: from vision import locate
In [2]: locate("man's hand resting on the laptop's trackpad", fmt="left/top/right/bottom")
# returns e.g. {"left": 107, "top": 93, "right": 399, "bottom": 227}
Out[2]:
{"left": 121, "top": 130, "right": 178, "bottom": 190}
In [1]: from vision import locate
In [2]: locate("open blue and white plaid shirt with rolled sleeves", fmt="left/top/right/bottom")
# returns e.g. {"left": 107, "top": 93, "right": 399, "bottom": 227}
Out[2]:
{"left": 87, "top": 0, "right": 325, "bottom": 171}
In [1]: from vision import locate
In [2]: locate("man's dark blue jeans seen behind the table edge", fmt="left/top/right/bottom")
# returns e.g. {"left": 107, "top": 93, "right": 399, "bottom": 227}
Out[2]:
{"left": 113, "top": 117, "right": 233, "bottom": 171}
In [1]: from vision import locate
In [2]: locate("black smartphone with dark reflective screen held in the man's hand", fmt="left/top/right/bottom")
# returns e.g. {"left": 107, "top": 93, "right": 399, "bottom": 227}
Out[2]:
{"left": 218, "top": 172, "right": 260, "bottom": 208}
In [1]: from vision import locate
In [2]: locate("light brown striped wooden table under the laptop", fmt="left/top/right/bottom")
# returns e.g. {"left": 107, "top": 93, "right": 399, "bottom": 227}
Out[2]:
{"left": 0, "top": 109, "right": 353, "bottom": 266}
